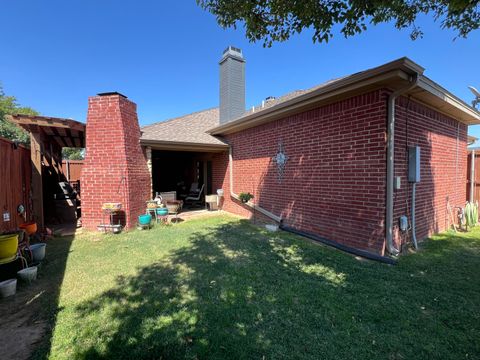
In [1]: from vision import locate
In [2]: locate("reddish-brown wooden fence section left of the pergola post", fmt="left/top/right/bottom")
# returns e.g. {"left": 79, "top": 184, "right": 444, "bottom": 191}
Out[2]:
{"left": 0, "top": 138, "right": 32, "bottom": 232}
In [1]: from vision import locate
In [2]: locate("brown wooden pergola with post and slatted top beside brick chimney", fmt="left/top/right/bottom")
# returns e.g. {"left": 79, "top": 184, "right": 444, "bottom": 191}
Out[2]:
{"left": 7, "top": 115, "right": 85, "bottom": 228}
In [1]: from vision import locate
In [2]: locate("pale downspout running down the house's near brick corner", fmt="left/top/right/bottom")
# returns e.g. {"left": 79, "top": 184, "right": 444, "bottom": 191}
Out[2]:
{"left": 385, "top": 74, "right": 418, "bottom": 256}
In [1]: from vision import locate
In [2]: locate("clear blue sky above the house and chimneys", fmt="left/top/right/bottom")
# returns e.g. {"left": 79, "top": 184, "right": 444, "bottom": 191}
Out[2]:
{"left": 0, "top": 0, "right": 480, "bottom": 137}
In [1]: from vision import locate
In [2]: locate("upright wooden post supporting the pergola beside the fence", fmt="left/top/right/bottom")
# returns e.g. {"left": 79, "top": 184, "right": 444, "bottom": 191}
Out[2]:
{"left": 30, "top": 132, "right": 44, "bottom": 229}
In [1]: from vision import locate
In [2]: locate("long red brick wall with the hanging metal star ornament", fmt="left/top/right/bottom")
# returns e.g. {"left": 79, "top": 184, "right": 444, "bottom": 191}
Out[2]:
{"left": 214, "top": 91, "right": 386, "bottom": 252}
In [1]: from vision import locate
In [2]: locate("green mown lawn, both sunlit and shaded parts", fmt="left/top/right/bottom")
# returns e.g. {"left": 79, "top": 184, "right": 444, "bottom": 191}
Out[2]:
{"left": 36, "top": 216, "right": 480, "bottom": 359}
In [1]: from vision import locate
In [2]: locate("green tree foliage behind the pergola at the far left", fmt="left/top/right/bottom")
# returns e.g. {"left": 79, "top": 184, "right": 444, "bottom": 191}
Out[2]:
{"left": 0, "top": 84, "right": 38, "bottom": 145}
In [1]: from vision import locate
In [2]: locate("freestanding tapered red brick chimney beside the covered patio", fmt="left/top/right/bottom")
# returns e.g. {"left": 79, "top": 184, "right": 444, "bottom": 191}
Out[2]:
{"left": 81, "top": 93, "right": 151, "bottom": 230}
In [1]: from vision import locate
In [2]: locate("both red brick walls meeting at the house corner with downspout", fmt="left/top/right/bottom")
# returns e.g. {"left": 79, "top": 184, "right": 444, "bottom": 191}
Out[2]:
{"left": 213, "top": 90, "right": 467, "bottom": 253}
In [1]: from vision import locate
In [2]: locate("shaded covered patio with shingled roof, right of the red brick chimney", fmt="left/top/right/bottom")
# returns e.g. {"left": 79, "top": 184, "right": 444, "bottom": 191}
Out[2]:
{"left": 140, "top": 109, "right": 228, "bottom": 208}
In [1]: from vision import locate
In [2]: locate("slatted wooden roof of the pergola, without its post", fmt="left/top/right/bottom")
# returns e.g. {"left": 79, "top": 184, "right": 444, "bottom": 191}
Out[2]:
{"left": 7, "top": 115, "right": 85, "bottom": 148}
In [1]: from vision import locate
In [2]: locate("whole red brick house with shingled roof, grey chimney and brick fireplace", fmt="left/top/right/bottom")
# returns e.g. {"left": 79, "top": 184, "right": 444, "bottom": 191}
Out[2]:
{"left": 82, "top": 47, "right": 480, "bottom": 254}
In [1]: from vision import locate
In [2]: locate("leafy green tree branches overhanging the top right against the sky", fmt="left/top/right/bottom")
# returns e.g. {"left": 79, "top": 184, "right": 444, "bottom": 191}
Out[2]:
{"left": 197, "top": 0, "right": 480, "bottom": 47}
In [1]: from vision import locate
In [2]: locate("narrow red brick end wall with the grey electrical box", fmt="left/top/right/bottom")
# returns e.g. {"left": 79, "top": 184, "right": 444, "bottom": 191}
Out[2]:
{"left": 394, "top": 98, "right": 467, "bottom": 249}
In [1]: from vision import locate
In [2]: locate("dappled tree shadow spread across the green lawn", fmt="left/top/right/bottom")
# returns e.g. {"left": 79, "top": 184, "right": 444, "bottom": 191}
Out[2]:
{"left": 64, "top": 221, "right": 480, "bottom": 359}
